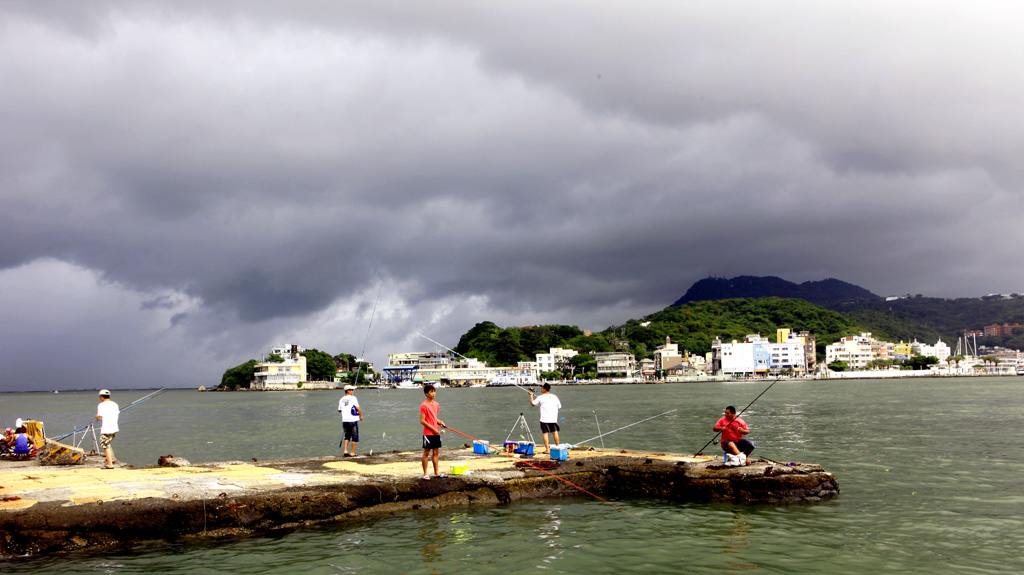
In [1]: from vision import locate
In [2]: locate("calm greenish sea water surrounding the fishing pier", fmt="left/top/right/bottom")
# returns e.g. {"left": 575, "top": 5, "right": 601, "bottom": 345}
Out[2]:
{"left": 0, "top": 378, "right": 1024, "bottom": 575}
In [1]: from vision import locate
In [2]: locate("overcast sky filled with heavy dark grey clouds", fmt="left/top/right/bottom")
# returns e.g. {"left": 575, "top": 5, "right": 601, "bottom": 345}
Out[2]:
{"left": 0, "top": 0, "right": 1024, "bottom": 391}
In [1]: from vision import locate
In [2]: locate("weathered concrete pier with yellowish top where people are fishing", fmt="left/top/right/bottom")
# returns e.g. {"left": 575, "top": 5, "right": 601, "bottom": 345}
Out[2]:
{"left": 0, "top": 446, "right": 839, "bottom": 557}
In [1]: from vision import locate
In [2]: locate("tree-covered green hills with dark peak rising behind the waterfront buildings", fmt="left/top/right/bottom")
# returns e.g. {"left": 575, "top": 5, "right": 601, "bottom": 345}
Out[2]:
{"left": 456, "top": 277, "right": 1024, "bottom": 365}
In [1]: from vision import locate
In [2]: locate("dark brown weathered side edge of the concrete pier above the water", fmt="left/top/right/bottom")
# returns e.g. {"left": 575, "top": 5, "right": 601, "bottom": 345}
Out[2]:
{"left": 0, "top": 455, "right": 839, "bottom": 557}
